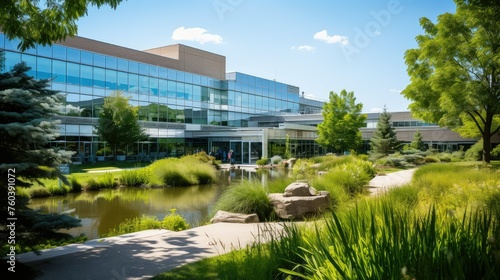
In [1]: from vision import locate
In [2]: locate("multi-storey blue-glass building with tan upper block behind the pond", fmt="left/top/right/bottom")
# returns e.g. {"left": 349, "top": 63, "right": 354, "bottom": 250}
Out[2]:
{"left": 0, "top": 33, "right": 323, "bottom": 163}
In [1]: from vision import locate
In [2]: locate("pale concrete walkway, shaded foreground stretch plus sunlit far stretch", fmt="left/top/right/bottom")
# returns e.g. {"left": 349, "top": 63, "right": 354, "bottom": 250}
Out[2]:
{"left": 17, "top": 169, "right": 415, "bottom": 280}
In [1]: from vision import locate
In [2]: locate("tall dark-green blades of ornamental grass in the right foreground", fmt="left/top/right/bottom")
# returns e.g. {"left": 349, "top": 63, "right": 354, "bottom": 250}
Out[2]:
{"left": 281, "top": 200, "right": 500, "bottom": 279}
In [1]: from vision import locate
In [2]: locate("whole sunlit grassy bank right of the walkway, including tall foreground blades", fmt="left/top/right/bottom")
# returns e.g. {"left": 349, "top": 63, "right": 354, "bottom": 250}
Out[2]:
{"left": 155, "top": 164, "right": 500, "bottom": 279}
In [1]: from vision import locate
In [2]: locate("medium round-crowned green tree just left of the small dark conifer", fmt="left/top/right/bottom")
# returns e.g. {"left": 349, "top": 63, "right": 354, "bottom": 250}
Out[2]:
{"left": 316, "top": 90, "right": 366, "bottom": 152}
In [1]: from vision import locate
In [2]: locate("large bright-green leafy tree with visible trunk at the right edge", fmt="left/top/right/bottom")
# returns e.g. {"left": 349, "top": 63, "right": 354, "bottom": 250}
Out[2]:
{"left": 402, "top": 0, "right": 500, "bottom": 163}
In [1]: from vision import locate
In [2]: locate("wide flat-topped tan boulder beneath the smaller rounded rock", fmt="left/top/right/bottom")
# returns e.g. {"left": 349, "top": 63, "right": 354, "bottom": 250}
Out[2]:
{"left": 268, "top": 191, "right": 330, "bottom": 219}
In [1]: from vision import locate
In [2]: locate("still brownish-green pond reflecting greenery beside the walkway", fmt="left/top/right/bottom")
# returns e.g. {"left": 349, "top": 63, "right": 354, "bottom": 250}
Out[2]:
{"left": 30, "top": 169, "right": 288, "bottom": 239}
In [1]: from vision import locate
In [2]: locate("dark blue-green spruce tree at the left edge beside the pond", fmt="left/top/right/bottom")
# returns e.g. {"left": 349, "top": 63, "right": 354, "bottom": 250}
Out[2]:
{"left": 0, "top": 63, "right": 79, "bottom": 255}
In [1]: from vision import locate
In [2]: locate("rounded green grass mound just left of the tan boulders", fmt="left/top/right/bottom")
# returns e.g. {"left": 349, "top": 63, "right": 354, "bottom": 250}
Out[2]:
{"left": 211, "top": 181, "right": 273, "bottom": 221}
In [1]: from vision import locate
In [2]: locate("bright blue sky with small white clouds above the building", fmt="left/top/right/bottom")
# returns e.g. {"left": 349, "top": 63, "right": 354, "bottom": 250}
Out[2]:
{"left": 78, "top": 0, "right": 455, "bottom": 112}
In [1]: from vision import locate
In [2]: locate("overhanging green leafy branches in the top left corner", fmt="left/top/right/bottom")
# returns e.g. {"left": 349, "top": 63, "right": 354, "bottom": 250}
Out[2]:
{"left": 0, "top": 0, "right": 123, "bottom": 51}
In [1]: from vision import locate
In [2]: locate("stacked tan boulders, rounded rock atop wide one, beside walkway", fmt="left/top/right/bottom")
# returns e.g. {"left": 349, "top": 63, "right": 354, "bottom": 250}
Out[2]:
{"left": 268, "top": 182, "right": 331, "bottom": 220}
